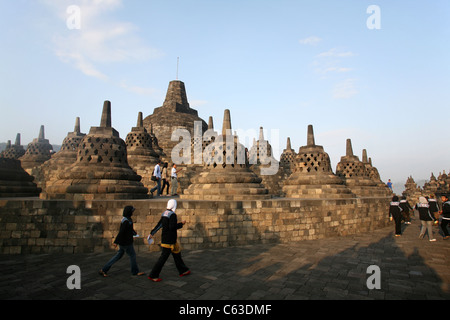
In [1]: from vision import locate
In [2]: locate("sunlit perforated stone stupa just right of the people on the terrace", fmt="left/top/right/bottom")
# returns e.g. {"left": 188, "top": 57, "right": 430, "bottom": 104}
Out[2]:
{"left": 180, "top": 110, "right": 270, "bottom": 200}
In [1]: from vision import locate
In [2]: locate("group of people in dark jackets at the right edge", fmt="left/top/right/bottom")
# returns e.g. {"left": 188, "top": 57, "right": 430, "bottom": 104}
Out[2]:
{"left": 389, "top": 195, "right": 450, "bottom": 241}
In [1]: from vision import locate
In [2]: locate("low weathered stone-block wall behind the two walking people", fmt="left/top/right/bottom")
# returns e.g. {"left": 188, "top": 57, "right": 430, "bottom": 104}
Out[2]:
{"left": 0, "top": 197, "right": 389, "bottom": 254}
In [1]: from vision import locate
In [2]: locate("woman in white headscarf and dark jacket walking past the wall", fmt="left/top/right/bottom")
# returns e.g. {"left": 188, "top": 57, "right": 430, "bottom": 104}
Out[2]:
{"left": 148, "top": 199, "right": 191, "bottom": 282}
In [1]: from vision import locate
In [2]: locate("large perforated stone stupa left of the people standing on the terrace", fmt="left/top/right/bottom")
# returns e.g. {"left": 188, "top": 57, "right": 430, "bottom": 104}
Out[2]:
{"left": 41, "top": 101, "right": 148, "bottom": 200}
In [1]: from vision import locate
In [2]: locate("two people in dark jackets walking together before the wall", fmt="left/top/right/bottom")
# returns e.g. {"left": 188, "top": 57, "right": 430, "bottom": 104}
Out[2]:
{"left": 99, "top": 199, "right": 191, "bottom": 282}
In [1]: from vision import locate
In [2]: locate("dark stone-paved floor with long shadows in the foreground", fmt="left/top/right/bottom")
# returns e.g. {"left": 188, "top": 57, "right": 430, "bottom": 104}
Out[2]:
{"left": 0, "top": 212, "right": 450, "bottom": 303}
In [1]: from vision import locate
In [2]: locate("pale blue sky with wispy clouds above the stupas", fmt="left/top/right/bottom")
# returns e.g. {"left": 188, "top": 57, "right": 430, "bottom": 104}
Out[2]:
{"left": 0, "top": 0, "right": 450, "bottom": 192}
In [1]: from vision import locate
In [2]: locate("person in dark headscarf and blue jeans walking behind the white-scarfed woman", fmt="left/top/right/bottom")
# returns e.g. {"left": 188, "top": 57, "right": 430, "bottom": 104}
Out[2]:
{"left": 99, "top": 206, "right": 145, "bottom": 277}
